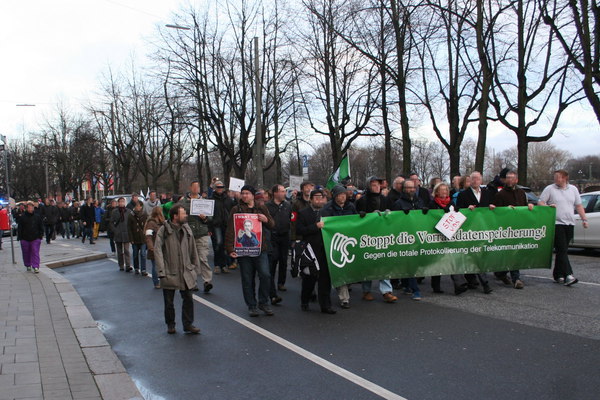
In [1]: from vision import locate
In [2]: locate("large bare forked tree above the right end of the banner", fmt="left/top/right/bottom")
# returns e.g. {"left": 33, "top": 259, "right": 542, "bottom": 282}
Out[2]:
{"left": 490, "top": 0, "right": 578, "bottom": 185}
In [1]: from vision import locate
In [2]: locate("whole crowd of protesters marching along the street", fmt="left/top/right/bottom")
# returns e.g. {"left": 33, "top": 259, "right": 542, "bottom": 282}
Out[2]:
{"left": 7, "top": 169, "right": 587, "bottom": 333}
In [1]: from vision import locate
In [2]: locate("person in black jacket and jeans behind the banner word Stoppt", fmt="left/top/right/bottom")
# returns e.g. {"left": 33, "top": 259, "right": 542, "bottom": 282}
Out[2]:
{"left": 356, "top": 176, "right": 398, "bottom": 303}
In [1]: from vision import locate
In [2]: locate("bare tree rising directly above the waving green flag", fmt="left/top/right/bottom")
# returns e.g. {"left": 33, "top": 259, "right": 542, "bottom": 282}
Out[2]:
{"left": 301, "top": 0, "right": 379, "bottom": 165}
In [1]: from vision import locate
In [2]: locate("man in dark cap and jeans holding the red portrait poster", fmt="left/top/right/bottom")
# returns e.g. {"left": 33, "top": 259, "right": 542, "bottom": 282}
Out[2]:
{"left": 225, "top": 185, "right": 275, "bottom": 317}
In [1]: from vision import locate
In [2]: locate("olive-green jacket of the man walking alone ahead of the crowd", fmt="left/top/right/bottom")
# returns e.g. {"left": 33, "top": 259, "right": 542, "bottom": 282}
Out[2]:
{"left": 154, "top": 221, "right": 200, "bottom": 290}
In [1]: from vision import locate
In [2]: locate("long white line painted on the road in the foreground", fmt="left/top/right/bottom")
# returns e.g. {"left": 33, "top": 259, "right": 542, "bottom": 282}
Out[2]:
{"left": 193, "top": 295, "right": 406, "bottom": 400}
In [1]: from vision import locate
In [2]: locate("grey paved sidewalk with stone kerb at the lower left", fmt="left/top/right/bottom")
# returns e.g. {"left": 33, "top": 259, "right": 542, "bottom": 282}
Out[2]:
{"left": 0, "top": 237, "right": 142, "bottom": 400}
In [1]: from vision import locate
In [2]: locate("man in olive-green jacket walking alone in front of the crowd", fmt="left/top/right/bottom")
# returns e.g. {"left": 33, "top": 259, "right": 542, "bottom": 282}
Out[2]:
{"left": 154, "top": 204, "right": 200, "bottom": 334}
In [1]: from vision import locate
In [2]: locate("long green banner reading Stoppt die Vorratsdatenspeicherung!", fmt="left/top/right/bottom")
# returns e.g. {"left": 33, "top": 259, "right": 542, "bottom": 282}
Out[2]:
{"left": 321, "top": 207, "right": 556, "bottom": 286}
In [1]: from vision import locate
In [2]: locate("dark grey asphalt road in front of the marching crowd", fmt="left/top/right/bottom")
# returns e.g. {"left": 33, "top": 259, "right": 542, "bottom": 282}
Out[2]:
{"left": 58, "top": 239, "right": 600, "bottom": 400}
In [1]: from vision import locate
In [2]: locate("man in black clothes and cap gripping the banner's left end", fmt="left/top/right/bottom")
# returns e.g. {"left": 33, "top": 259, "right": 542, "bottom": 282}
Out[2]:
{"left": 296, "top": 189, "right": 335, "bottom": 314}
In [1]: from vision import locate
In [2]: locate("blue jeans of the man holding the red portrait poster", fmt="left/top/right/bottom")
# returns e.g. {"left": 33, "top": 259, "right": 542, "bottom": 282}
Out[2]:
{"left": 237, "top": 252, "right": 271, "bottom": 308}
